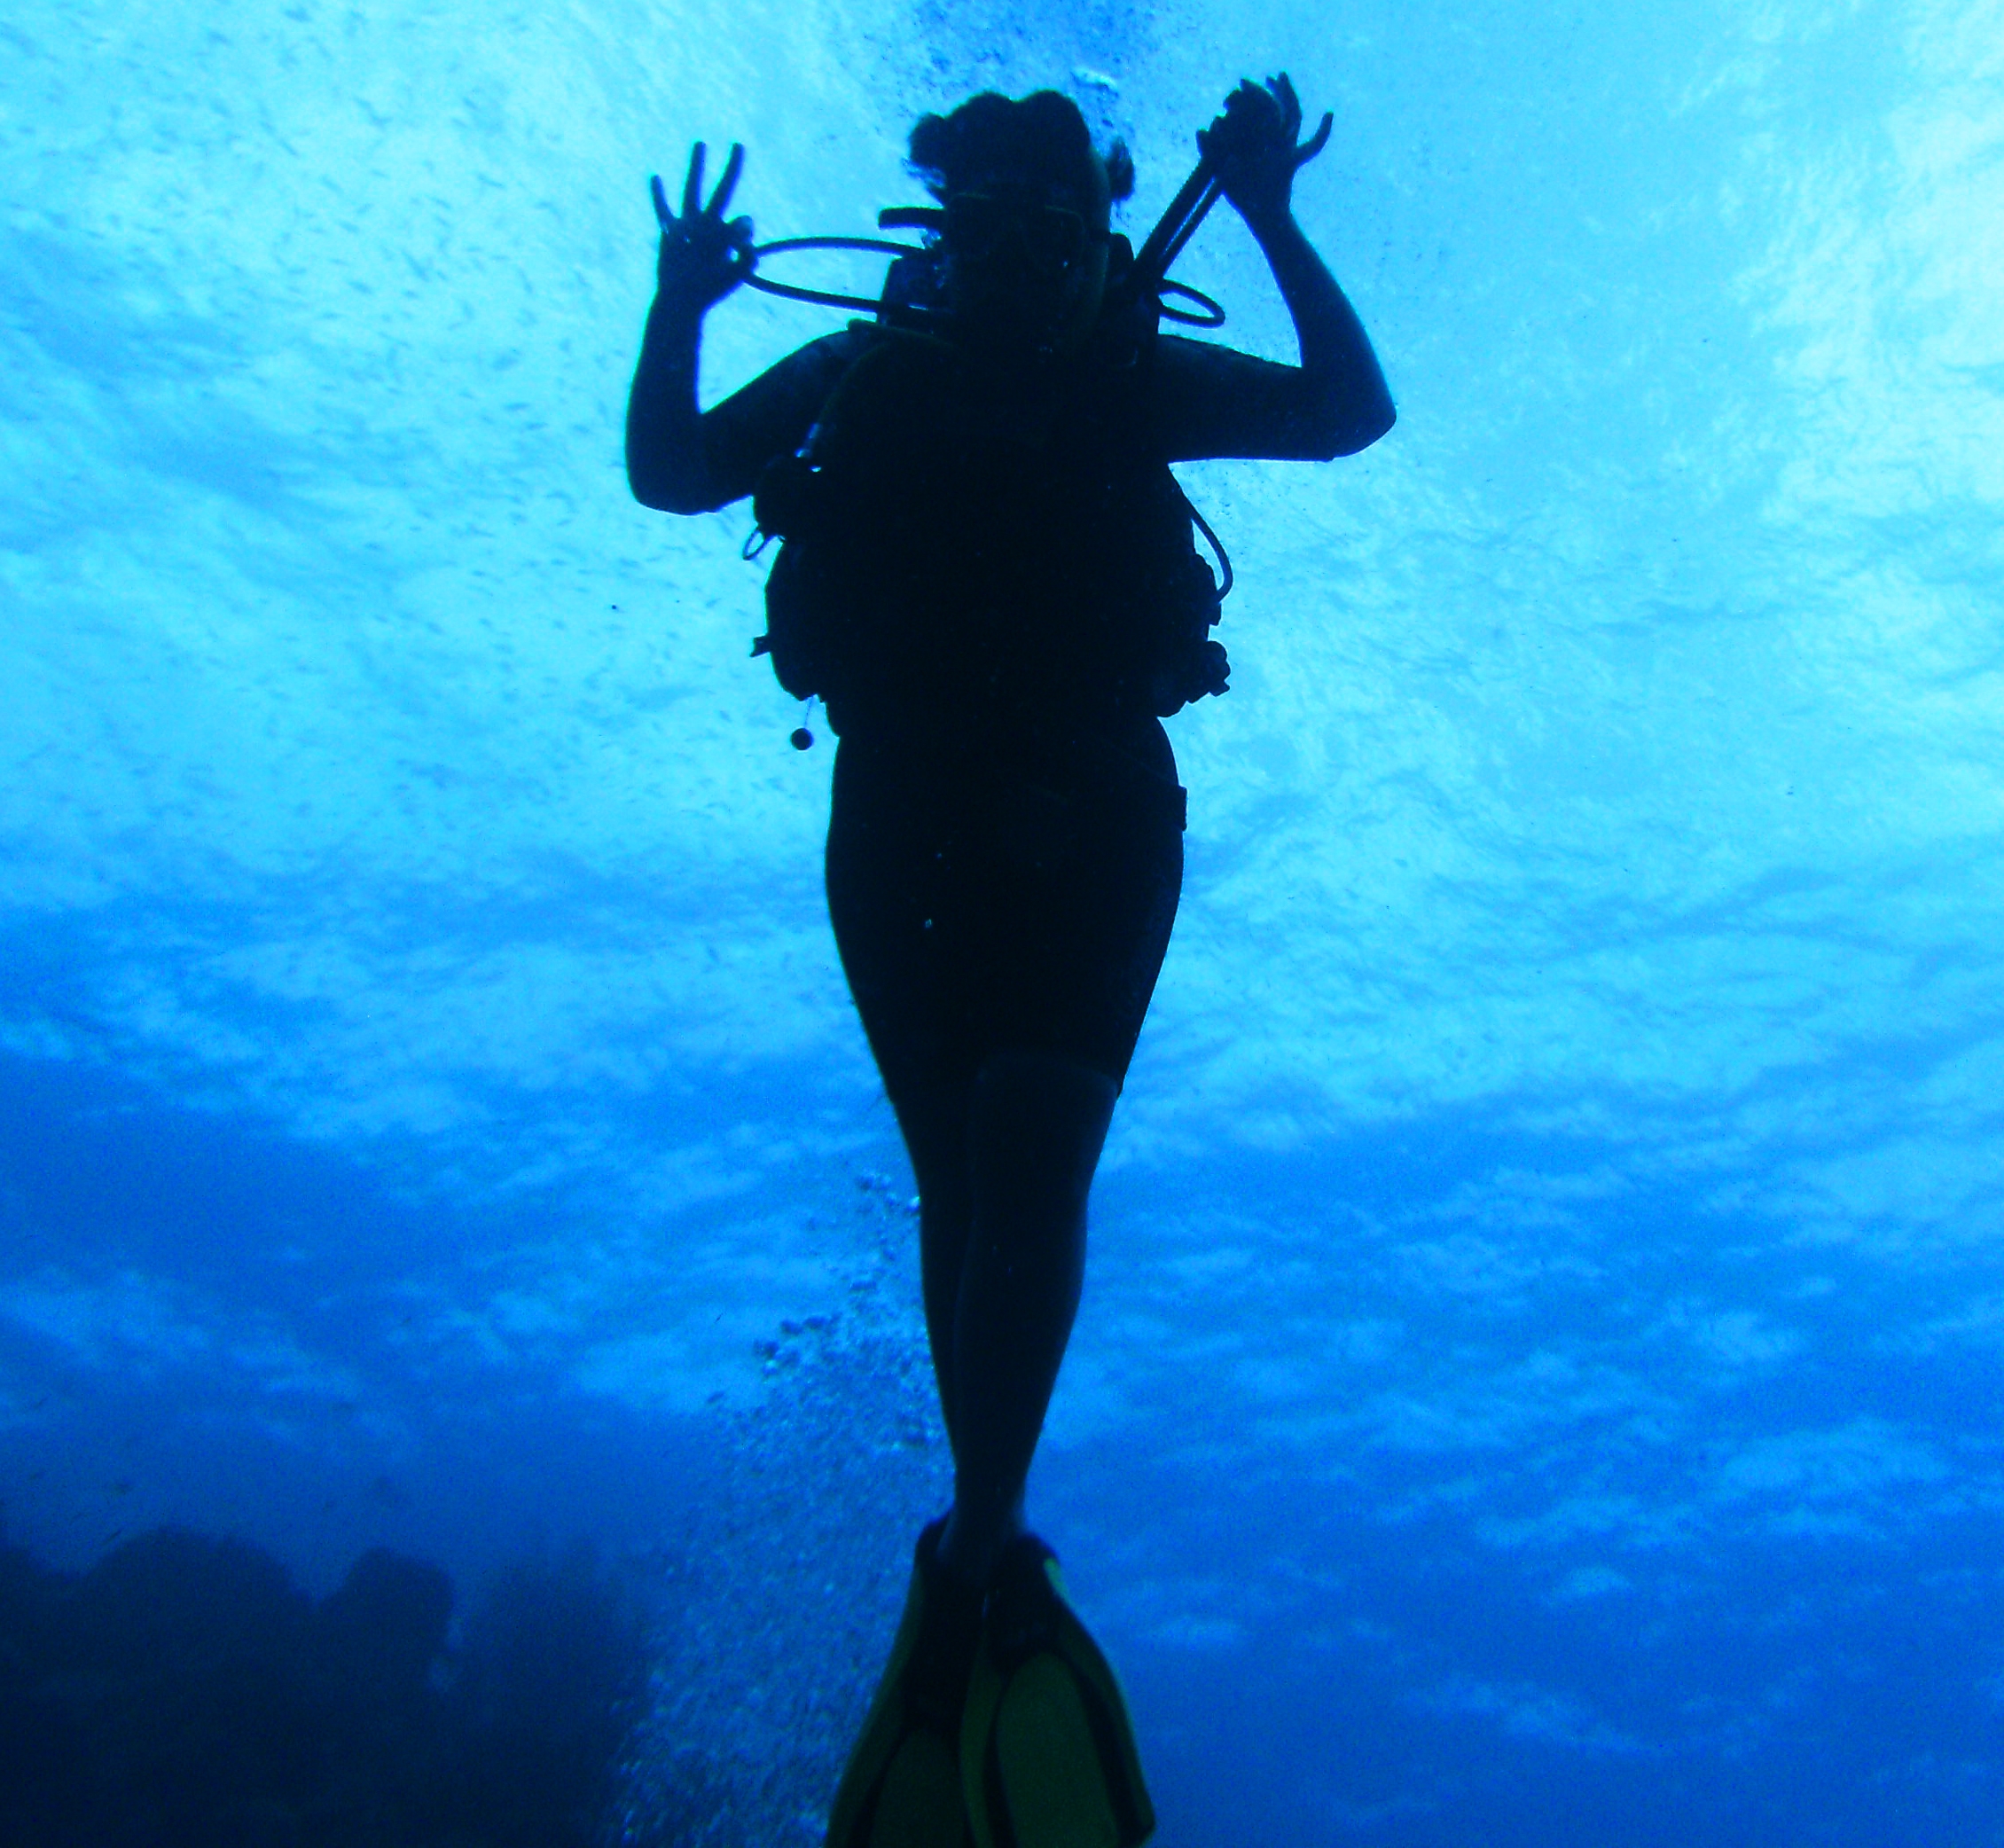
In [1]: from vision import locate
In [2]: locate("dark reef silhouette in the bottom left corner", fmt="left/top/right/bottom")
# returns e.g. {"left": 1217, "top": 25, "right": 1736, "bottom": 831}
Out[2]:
{"left": 0, "top": 1527, "right": 647, "bottom": 1848}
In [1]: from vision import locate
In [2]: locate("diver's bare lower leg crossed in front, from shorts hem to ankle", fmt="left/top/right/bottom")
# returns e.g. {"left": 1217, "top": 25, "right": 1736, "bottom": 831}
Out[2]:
{"left": 940, "top": 1053, "right": 1116, "bottom": 1581}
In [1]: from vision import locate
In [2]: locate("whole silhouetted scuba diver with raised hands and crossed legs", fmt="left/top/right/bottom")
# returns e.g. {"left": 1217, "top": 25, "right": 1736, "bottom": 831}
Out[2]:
{"left": 625, "top": 76, "right": 1395, "bottom": 1848}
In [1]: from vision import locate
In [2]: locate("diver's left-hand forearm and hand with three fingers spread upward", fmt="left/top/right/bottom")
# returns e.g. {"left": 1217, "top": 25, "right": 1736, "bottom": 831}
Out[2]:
{"left": 627, "top": 142, "right": 752, "bottom": 513}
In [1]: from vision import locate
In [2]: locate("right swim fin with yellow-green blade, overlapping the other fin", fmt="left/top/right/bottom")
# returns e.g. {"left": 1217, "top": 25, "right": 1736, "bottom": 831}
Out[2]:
{"left": 960, "top": 1533, "right": 1155, "bottom": 1848}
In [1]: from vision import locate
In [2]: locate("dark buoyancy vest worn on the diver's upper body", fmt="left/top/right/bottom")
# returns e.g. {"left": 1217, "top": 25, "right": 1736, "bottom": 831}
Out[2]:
{"left": 754, "top": 288, "right": 1231, "bottom": 738}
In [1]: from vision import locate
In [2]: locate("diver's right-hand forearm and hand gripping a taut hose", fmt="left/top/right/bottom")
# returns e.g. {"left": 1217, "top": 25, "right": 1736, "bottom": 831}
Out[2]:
{"left": 1196, "top": 74, "right": 1397, "bottom": 459}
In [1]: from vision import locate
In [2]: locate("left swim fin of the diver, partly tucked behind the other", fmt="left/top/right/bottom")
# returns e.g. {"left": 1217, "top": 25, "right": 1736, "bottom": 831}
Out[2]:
{"left": 827, "top": 1519, "right": 982, "bottom": 1848}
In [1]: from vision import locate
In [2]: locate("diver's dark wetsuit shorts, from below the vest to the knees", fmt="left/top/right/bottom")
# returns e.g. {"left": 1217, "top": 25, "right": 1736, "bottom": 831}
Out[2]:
{"left": 827, "top": 719, "right": 1185, "bottom": 1107}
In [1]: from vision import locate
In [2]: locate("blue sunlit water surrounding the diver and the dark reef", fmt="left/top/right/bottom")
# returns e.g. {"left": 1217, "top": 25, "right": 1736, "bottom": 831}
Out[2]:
{"left": 0, "top": 0, "right": 2004, "bottom": 1848}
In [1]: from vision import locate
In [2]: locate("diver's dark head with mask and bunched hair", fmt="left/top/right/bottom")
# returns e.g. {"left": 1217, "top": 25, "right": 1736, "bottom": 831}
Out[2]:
{"left": 912, "top": 90, "right": 1134, "bottom": 353}
